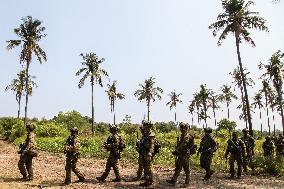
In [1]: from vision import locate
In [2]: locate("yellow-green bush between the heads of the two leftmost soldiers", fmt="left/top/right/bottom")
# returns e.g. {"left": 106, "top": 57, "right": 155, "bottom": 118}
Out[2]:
{"left": 35, "top": 122, "right": 68, "bottom": 137}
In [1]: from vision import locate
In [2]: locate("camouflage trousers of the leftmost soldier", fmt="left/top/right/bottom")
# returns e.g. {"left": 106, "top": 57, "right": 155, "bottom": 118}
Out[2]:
{"left": 18, "top": 153, "right": 33, "bottom": 180}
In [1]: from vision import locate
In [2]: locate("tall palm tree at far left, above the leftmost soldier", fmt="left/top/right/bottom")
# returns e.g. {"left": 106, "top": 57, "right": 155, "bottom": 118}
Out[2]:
{"left": 7, "top": 16, "right": 46, "bottom": 124}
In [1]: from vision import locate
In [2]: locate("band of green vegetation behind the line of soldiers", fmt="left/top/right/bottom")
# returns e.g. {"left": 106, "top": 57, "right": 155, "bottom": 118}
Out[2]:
{"left": 0, "top": 111, "right": 284, "bottom": 176}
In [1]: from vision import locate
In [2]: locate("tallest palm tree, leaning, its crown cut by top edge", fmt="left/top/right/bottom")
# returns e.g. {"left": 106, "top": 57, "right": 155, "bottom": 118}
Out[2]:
{"left": 209, "top": 0, "right": 268, "bottom": 135}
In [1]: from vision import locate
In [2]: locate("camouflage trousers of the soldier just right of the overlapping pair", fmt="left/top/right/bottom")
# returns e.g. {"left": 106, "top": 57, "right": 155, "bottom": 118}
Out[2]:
{"left": 172, "top": 156, "right": 190, "bottom": 184}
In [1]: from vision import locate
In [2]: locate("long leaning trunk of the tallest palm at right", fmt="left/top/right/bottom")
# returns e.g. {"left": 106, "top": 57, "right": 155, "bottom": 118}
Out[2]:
{"left": 235, "top": 33, "right": 253, "bottom": 136}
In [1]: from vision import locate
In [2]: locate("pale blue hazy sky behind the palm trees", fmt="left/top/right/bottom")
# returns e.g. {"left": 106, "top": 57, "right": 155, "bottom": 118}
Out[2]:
{"left": 0, "top": 0, "right": 284, "bottom": 129}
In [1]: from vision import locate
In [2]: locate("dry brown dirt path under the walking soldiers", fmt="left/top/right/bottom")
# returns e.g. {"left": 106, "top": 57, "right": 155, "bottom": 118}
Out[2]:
{"left": 0, "top": 140, "right": 284, "bottom": 189}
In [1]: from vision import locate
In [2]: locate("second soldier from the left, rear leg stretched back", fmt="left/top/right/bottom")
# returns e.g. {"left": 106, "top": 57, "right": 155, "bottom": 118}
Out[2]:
{"left": 64, "top": 127, "right": 85, "bottom": 185}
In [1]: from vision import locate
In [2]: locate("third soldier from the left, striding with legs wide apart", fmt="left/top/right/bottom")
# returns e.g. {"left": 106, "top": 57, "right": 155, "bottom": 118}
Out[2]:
{"left": 97, "top": 125, "right": 125, "bottom": 182}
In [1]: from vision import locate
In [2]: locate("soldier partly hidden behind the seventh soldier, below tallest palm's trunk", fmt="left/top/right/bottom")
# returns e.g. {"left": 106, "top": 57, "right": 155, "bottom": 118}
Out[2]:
{"left": 241, "top": 128, "right": 255, "bottom": 172}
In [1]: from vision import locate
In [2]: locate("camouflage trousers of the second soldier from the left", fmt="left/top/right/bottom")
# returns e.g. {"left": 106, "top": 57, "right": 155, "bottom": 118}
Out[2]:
{"left": 65, "top": 156, "right": 84, "bottom": 183}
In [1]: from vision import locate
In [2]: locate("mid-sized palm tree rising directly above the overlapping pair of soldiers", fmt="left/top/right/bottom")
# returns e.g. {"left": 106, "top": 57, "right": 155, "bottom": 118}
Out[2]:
{"left": 134, "top": 77, "right": 163, "bottom": 121}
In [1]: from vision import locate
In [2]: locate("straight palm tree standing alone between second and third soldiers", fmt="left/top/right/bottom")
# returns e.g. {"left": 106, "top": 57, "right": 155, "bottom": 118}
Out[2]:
{"left": 76, "top": 52, "right": 108, "bottom": 134}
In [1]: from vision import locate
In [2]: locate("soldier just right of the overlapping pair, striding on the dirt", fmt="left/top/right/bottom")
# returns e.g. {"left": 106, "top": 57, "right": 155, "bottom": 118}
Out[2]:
{"left": 167, "top": 122, "right": 196, "bottom": 186}
